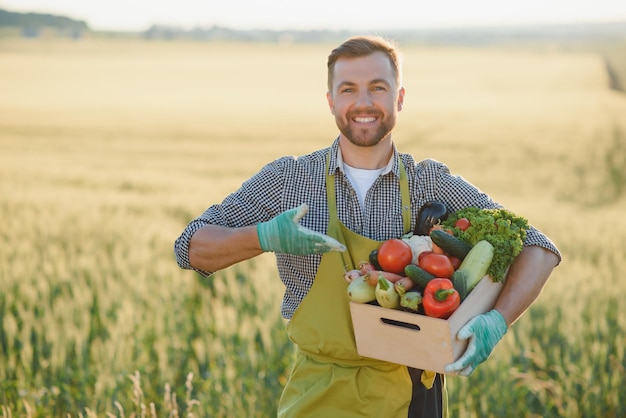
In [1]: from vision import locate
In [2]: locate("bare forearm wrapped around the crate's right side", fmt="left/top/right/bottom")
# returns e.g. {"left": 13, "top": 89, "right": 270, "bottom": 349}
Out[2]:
{"left": 494, "top": 246, "right": 558, "bottom": 326}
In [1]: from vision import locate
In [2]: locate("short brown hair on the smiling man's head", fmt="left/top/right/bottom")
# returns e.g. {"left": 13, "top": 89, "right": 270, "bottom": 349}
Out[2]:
{"left": 328, "top": 36, "right": 402, "bottom": 91}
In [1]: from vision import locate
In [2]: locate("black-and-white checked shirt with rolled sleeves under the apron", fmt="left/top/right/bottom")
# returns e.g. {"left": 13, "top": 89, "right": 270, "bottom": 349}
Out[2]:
{"left": 174, "top": 140, "right": 561, "bottom": 319}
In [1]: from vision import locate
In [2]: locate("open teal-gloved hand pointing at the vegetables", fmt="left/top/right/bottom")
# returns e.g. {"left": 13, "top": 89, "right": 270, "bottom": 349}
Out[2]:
{"left": 257, "top": 204, "right": 346, "bottom": 255}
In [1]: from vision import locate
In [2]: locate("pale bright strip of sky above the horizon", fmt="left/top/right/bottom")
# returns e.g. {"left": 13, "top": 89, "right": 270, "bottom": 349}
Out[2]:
{"left": 0, "top": 0, "right": 626, "bottom": 31}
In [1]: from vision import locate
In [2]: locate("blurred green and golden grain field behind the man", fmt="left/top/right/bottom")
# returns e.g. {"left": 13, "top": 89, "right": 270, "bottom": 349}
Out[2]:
{"left": 0, "top": 39, "right": 626, "bottom": 417}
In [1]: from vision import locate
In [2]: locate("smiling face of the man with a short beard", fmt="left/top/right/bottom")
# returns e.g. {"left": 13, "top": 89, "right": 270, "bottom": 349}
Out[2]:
{"left": 327, "top": 52, "right": 404, "bottom": 147}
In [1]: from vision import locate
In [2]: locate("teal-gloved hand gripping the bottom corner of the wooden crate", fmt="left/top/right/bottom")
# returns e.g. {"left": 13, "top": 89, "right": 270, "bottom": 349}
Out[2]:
{"left": 444, "top": 309, "right": 508, "bottom": 376}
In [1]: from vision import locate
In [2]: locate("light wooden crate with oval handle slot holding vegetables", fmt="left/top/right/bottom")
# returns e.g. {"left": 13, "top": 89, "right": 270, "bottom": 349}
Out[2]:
{"left": 350, "top": 276, "right": 502, "bottom": 373}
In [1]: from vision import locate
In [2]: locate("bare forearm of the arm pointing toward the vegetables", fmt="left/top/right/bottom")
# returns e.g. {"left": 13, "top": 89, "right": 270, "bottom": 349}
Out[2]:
{"left": 189, "top": 225, "right": 263, "bottom": 272}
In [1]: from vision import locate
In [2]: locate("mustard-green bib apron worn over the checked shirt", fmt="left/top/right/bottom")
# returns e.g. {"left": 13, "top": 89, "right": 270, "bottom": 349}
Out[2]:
{"left": 278, "top": 158, "right": 412, "bottom": 418}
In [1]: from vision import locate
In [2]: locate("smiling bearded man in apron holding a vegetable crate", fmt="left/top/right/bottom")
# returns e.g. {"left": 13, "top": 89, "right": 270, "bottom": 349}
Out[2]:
{"left": 175, "top": 37, "right": 560, "bottom": 417}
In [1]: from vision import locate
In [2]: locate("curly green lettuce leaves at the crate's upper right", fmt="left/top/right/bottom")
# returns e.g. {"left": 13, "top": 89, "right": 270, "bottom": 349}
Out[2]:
{"left": 442, "top": 207, "right": 529, "bottom": 282}
